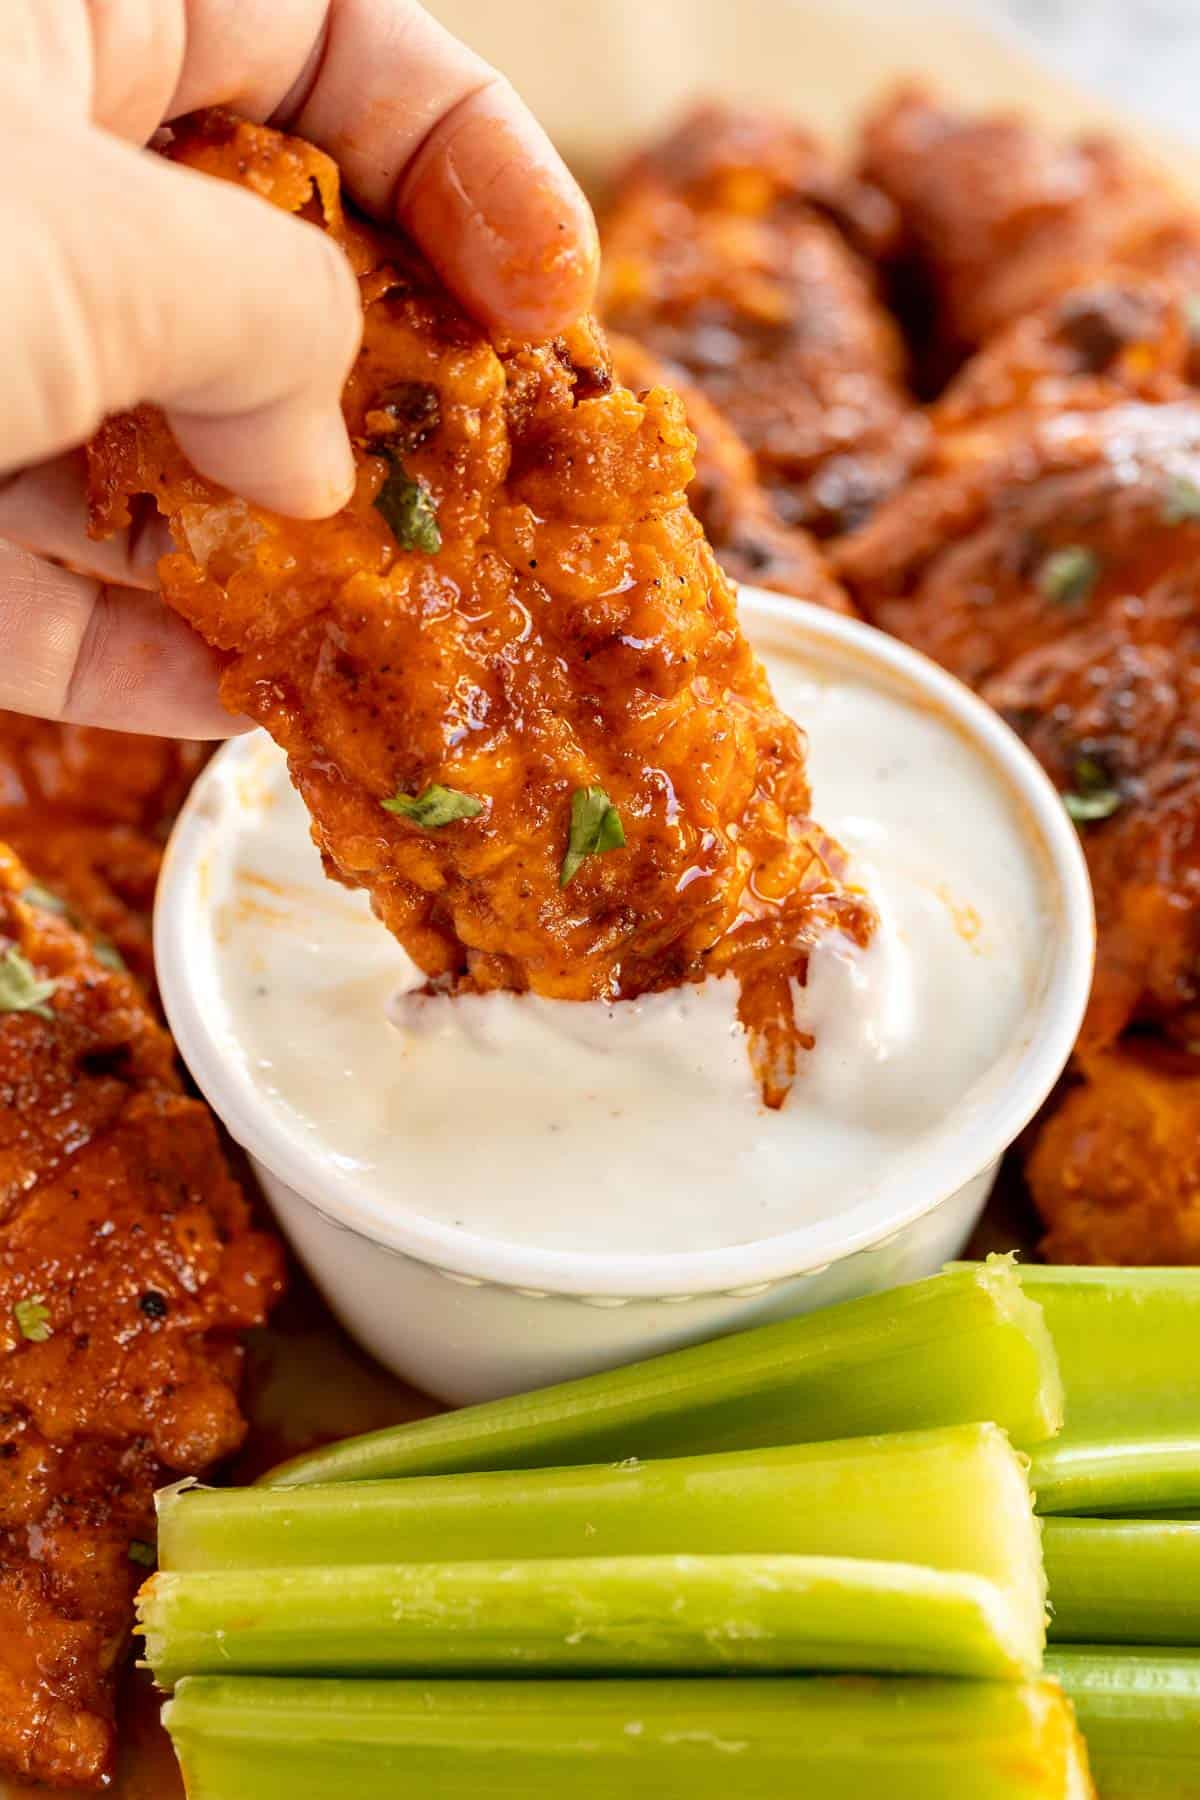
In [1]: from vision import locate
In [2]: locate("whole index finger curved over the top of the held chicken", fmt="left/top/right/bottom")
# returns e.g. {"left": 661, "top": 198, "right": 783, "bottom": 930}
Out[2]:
{"left": 167, "top": 0, "right": 597, "bottom": 338}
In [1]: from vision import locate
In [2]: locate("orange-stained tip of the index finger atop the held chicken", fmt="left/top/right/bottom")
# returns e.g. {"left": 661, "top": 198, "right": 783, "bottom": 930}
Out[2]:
{"left": 396, "top": 81, "right": 599, "bottom": 340}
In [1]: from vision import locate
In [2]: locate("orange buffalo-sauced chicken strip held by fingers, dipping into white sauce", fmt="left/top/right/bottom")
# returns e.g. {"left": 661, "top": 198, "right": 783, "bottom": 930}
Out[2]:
{"left": 90, "top": 113, "right": 874, "bottom": 1105}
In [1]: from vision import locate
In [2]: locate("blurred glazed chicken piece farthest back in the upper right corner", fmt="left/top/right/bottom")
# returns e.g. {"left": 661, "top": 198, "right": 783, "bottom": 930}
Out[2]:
{"left": 862, "top": 88, "right": 1200, "bottom": 367}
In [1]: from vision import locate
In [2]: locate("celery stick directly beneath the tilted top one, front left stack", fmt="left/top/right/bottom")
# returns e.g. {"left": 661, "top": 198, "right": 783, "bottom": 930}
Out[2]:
{"left": 158, "top": 1426, "right": 1045, "bottom": 1629}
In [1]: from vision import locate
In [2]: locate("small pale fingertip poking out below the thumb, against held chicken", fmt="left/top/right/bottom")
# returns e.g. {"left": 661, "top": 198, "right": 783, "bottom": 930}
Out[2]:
{"left": 169, "top": 405, "right": 354, "bottom": 518}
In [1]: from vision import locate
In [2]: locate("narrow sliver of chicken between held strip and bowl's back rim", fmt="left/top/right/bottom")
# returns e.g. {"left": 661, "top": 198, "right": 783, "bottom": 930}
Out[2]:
{"left": 610, "top": 333, "right": 853, "bottom": 612}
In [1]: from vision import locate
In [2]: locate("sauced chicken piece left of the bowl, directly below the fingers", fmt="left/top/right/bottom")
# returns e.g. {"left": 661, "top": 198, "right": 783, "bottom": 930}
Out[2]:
{"left": 0, "top": 713, "right": 210, "bottom": 988}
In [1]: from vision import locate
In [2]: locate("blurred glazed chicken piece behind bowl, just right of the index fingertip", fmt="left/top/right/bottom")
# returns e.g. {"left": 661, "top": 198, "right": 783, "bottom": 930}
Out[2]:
{"left": 601, "top": 106, "right": 923, "bottom": 536}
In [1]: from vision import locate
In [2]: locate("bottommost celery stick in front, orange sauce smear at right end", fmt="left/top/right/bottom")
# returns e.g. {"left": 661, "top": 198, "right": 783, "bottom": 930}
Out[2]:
{"left": 164, "top": 1678, "right": 1092, "bottom": 1800}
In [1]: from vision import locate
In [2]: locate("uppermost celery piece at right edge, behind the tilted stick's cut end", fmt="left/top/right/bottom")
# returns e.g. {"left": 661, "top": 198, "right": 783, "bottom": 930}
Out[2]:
{"left": 964, "top": 1265, "right": 1200, "bottom": 1514}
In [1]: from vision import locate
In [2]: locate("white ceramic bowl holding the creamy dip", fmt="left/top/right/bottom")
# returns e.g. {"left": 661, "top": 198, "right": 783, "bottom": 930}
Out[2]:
{"left": 155, "top": 589, "right": 1094, "bottom": 1402}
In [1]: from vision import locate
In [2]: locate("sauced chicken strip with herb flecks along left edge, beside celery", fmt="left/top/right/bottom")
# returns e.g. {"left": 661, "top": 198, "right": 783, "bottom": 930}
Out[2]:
{"left": 0, "top": 848, "right": 281, "bottom": 1786}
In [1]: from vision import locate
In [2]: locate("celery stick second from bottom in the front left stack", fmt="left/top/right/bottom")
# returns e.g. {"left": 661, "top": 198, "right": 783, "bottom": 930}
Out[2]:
{"left": 139, "top": 1555, "right": 1042, "bottom": 1688}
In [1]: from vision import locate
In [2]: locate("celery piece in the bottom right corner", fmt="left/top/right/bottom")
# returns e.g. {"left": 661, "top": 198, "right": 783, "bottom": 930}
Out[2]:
{"left": 1045, "top": 1643, "right": 1200, "bottom": 1800}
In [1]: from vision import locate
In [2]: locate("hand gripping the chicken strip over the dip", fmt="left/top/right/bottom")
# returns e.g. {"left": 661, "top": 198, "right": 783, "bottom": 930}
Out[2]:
{"left": 0, "top": 0, "right": 596, "bottom": 736}
